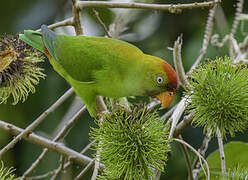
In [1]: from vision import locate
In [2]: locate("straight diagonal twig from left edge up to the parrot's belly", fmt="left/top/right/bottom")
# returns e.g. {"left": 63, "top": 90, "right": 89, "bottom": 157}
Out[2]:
{"left": 0, "top": 88, "right": 74, "bottom": 159}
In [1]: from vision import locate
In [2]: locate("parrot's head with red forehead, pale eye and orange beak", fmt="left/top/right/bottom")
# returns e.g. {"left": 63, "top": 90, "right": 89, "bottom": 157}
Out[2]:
{"left": 142, "top": 55, "right": 179, "bottom": 109}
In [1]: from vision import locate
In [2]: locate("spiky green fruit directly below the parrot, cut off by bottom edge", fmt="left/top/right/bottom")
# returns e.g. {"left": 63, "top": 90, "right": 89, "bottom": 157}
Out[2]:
{"left": 91, "top": 108, "right": 170, "bottom": 180}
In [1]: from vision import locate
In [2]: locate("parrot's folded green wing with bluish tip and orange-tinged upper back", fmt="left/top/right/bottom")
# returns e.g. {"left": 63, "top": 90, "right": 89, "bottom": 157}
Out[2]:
{"left": 41, "top": 25, "right": 143, "bottom": 82}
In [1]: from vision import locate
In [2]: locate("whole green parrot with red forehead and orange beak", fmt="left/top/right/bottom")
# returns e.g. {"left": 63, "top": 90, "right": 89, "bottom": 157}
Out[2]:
{"left": 19, "top": 25, "right": 179, "bottom": 117}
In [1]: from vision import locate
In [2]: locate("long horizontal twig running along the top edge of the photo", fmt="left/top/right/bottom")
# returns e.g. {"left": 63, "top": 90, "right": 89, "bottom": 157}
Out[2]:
{"left": 78, "top": 0, "right": 220, "bottom": 13}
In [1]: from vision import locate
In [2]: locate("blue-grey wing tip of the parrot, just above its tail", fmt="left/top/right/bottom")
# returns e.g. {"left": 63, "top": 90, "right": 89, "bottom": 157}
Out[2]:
{"left": 41, "top": 25, "right": 57, "bottom": 59}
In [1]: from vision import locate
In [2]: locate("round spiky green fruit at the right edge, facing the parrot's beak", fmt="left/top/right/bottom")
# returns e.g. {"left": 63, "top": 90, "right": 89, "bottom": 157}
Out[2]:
{"left": 187, "top": 57, "right": 248, "bottom": 136}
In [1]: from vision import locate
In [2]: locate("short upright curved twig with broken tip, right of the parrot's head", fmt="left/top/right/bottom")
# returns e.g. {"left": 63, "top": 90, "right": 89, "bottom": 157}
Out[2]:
{"left": 173, "top": 35, "right": 188, "bottom": 86}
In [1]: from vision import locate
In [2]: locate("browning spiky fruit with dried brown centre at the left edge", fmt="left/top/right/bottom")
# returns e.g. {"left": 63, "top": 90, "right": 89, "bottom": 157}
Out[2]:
{"left": 0, "top": 35, "right": 45, "bottom": 105}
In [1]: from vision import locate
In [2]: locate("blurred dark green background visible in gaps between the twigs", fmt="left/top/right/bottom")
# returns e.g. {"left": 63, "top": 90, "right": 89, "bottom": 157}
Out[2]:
{"left": 0, "top": 0, "right": 248, "bottom": 180}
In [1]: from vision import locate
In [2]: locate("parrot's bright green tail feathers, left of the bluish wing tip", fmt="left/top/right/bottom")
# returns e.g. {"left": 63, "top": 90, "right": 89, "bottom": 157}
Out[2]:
{"left": 19, "top": 30, "right": 44, "bottom": 53}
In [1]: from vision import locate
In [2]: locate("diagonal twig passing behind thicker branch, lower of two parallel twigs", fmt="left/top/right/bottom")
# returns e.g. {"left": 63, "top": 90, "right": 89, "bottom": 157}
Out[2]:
{"left": 20, "top": 106, "right": 86, "bottom": 180}
